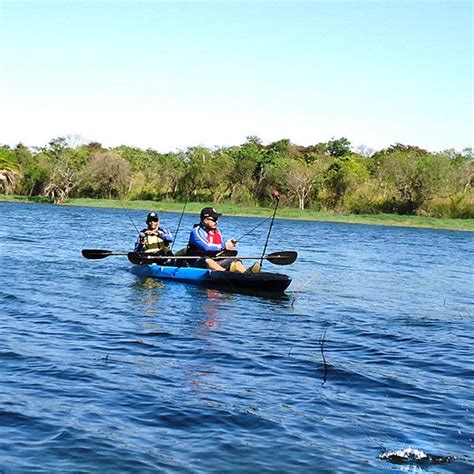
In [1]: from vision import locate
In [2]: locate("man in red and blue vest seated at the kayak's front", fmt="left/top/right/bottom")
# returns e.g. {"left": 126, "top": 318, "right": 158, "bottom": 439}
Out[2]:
{"left": 187, "top": 207, "right": 260, "bottom": 273}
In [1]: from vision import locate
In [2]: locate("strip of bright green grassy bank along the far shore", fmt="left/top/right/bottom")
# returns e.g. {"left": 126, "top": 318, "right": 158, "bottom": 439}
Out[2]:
{"left": 0, "top": 195, "right": 474, "bottom": 232}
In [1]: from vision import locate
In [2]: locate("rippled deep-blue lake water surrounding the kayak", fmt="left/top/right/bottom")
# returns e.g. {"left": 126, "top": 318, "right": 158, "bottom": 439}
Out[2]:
{"left": 0, "top": 203, "right": 474, "bottom": 473}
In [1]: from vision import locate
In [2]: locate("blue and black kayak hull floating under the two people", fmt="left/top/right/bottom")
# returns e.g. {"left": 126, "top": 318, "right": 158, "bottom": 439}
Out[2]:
{"left": 130, "top": 263, "right": 291, "bottom": 293}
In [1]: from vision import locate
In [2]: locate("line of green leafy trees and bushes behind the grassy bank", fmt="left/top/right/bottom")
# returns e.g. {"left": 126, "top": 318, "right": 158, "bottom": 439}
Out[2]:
{"left": 0, "top": 136, "right": 474, "bottom": 218}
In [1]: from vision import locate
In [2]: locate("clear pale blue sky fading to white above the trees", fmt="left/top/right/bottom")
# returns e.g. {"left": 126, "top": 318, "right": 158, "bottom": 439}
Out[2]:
{"left": 0, "top": 0, "right": 474, "bottom": 152}
